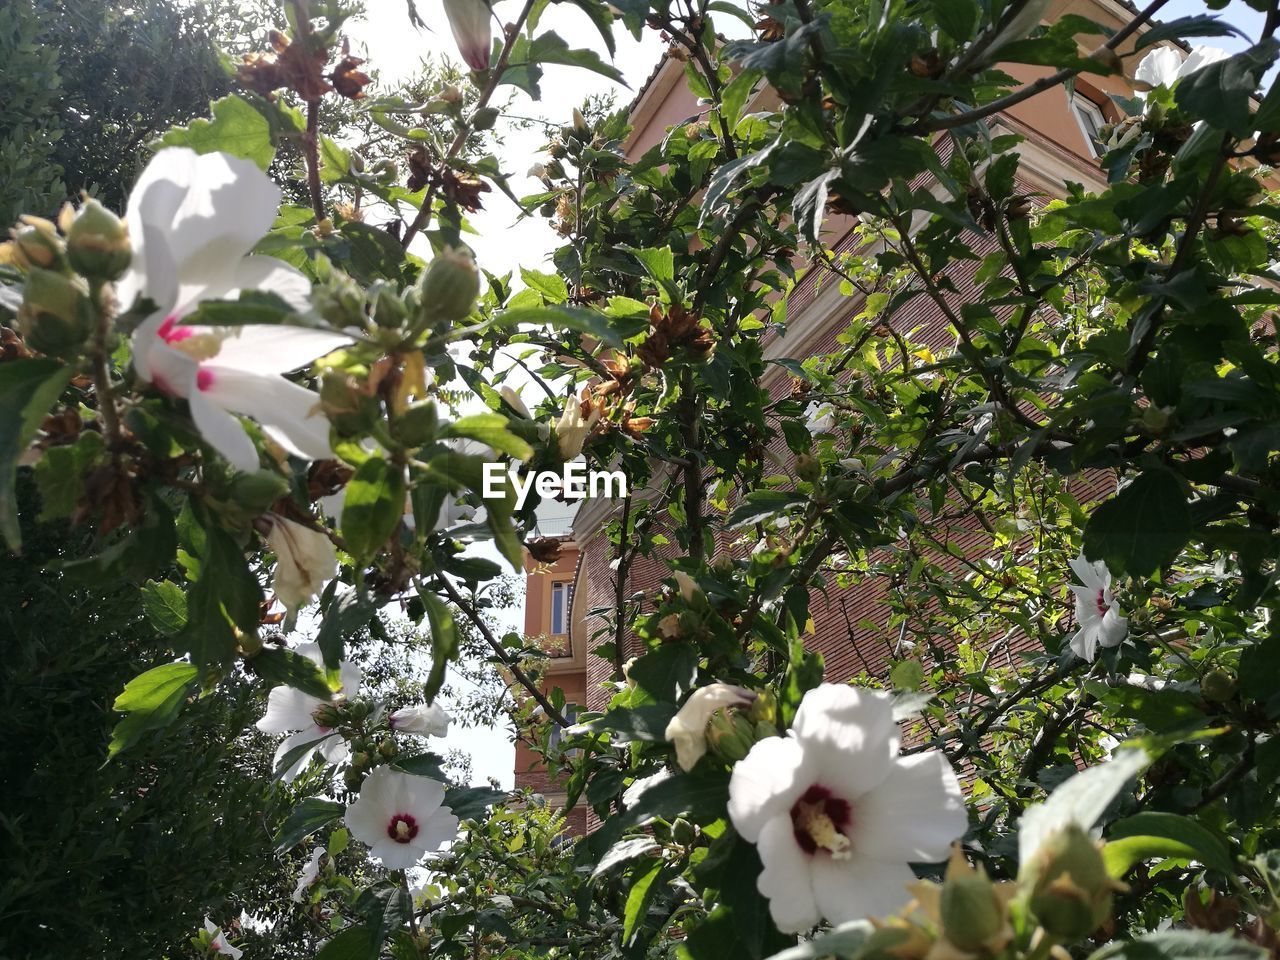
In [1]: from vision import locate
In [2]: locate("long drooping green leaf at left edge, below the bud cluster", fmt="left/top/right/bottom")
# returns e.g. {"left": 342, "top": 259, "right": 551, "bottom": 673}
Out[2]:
{"left": 0, "top": 357, "right": 72, "bottom": 550}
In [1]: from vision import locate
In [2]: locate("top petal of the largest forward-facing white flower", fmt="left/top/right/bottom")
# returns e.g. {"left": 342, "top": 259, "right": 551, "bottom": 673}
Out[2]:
{"left": 791, "top": 684, "right": 899, "bottom": 800}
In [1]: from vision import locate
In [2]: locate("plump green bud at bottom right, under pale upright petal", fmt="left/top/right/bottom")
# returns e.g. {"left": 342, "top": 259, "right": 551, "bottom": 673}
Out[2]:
{"left": 1029, "top": 823, "right": 1125, "bottom": 941}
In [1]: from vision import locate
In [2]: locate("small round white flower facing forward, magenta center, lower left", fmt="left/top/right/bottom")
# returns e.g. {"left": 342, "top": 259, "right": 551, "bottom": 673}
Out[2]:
{"left": 346, "top": 767, "right": 458, "bottom": 870}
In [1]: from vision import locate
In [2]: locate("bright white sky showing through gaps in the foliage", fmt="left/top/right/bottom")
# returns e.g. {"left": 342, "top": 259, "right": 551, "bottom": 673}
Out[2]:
{"left": 335, "top": 0, "right": 1262, "bottom": 787}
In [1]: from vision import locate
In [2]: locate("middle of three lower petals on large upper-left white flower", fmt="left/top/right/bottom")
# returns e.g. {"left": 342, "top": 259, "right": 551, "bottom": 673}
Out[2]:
{"left": 200, "top": 364, "right": 333, "bottom": 463}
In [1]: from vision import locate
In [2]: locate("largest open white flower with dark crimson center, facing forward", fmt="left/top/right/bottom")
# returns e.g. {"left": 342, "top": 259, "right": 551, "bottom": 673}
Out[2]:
{"left": 728, "top": 684, "right": 969, "bottom": 933}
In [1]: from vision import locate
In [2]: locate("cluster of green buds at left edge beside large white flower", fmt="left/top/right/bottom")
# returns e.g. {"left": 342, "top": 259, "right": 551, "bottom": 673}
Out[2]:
{"left": 0, "top": 198, "right": 133, "bottom": 357}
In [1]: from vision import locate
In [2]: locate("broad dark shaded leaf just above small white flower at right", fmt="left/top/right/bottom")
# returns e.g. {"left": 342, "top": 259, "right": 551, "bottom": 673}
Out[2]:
{"left": 1084, "top": 470, "right": 1192, "bottom": 576}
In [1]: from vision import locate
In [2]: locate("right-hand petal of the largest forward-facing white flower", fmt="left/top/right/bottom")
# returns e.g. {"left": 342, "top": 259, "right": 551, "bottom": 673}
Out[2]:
{"left": 851, "top": 750, "right": 969, "bottom": 863}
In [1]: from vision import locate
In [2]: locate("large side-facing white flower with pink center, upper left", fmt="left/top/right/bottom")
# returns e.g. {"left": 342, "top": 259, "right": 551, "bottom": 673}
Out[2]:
{"left": 116, "top": 147, "right": 351, "bottom": 471}
